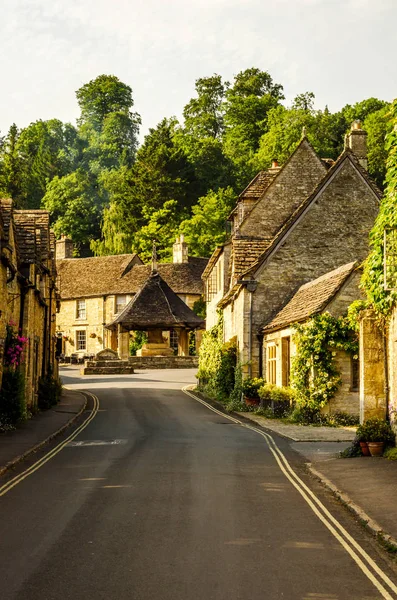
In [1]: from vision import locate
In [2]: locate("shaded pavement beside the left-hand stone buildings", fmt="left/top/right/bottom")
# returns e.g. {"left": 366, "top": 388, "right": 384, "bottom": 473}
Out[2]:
{"left": 0, "top": 388, "right": 86, "bottom": 475}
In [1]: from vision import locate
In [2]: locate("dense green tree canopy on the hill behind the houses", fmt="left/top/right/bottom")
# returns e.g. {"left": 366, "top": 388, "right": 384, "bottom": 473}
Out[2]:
{"left": 0, "top": 67, "right": 392, "bottom": 259}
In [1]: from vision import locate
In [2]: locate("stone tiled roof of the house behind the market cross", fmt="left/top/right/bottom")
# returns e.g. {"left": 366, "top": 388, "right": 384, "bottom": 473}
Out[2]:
{"left": 57, "top": 254, "right": 208, "bottom": 300}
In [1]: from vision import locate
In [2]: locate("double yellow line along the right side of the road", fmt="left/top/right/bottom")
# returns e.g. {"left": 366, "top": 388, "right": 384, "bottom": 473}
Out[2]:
{"left": 182, "top": 388, "right": 397, "bottom": 600}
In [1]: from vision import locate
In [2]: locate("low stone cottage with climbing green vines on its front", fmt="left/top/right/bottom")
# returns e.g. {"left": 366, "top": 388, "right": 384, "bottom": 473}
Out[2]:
{"left": 261, "top": 262, "right": 362, "bottom": 415}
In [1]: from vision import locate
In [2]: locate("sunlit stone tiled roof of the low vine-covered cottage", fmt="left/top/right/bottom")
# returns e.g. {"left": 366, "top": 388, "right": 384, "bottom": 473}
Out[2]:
{"left": 263, "top": 262, "right": 357, "bottom": 333}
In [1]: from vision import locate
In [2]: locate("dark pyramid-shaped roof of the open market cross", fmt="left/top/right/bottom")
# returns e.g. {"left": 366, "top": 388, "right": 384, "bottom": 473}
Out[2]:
{"left": 106, "top": 271, "right": 204, "bottom": 330}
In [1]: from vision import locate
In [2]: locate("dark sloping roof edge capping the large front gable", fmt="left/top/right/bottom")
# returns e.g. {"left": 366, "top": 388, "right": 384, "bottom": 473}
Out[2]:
{"left": 243, "top": 149, "right": 382, "bottom": 276}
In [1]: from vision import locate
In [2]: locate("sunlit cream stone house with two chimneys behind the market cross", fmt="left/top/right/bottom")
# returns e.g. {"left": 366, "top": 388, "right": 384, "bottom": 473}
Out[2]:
{"left": 57, "top": 236, "right": 208, "bottom": 357}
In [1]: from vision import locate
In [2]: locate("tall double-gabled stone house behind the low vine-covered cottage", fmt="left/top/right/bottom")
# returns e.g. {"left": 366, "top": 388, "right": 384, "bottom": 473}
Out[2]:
{"left": 203, "top": 122, "right": 381, "bottom": 375}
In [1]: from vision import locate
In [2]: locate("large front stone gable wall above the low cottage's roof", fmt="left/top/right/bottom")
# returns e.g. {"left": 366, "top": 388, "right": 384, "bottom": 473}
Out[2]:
{"left": 249, "top": 161, "right": 378, "bottom": 376}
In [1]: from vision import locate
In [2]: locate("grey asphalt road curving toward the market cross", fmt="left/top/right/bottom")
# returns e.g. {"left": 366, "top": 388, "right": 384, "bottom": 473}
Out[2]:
{"left": 0, "top": 369, "right": 397, "bottom": 600}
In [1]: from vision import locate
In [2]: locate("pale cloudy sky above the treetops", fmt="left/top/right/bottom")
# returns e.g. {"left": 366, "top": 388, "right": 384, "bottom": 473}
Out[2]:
{"left": 0, "top": 0, "right": 397, "bottom": 135}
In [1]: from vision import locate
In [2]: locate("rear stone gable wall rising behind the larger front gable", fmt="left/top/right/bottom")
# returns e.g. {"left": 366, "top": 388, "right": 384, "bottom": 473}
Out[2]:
{"left": 240, "top": 140, "right": 327, "bottom": 238}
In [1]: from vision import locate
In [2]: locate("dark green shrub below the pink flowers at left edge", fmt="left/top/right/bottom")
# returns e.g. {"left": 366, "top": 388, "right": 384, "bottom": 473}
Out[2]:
{"left": 0, "top": 368, "right": 27, "bottom": 429}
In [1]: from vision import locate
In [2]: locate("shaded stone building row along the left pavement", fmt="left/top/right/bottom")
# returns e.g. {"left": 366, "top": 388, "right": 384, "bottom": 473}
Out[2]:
{"left": 0, "top": 199, "right": 57, "bottom": 410}
